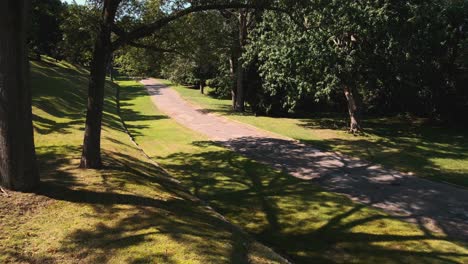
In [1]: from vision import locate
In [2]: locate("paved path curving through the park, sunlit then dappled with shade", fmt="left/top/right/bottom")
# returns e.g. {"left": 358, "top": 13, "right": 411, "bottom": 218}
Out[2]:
{"left": 142, "top": 79, "right": 468, "bottom": 241}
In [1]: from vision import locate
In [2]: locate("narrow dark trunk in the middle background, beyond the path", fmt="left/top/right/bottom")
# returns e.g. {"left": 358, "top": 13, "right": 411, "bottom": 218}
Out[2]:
{"left": 235, "top": 9, "right": 247, "bottom": 112}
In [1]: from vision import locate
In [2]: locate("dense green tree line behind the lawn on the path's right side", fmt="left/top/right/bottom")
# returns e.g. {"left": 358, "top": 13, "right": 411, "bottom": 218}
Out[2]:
{"left": 116, "top": 0, "right": 468, "bottom": 132}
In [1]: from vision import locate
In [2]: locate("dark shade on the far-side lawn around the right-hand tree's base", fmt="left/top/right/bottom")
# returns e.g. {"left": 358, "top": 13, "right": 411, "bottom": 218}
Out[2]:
{"left": 302, "top": 116, "right": 468, "bottom": 187}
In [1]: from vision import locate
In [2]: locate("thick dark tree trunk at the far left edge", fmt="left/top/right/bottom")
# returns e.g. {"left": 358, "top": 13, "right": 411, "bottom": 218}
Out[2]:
{"left": 0, "top": 0, "right": 39, "bottom": 191}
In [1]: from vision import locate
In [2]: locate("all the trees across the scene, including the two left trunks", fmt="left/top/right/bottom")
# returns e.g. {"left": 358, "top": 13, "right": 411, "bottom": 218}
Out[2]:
{"left": 0, "top": 0, "right": 468, "bottom": 191}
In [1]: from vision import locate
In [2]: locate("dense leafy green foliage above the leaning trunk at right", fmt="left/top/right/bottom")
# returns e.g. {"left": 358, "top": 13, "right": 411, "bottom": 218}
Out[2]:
{"left": 245, "top": 0, "right": 468, "bottom": 120}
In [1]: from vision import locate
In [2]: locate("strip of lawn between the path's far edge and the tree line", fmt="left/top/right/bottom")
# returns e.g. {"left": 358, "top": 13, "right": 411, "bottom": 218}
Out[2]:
{"left": 166, "top": 81, "right": 468, "bottom": 187}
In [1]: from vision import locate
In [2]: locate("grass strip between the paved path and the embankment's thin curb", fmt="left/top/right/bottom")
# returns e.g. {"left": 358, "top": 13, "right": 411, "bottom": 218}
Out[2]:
{"left": 119, "top": 81, "right": 468, "bottom": 263}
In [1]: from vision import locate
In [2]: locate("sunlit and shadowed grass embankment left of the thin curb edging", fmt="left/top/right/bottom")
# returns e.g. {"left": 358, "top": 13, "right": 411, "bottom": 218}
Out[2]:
{"left": 0, "top": 58, "right": 288, "bottom": 264}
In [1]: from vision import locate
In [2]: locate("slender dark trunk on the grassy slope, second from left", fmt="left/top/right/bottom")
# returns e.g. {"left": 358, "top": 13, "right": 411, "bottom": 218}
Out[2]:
{"left": 80, "top": 0, "right": 120, "bottom": 169}
